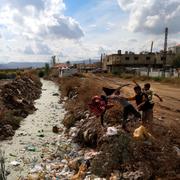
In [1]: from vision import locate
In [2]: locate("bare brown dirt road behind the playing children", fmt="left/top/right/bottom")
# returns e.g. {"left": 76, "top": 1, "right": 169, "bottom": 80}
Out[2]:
{"left": 88, "top": 74, "right": 180, "bottom": 146}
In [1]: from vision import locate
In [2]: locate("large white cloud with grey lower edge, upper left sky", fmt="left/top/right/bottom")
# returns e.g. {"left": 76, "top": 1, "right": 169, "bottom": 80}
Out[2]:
{"left": 0, "top": 0, "right": 84, "bottom": 39}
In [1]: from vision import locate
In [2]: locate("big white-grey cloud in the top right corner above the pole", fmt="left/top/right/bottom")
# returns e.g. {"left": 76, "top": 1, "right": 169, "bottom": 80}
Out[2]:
{"left": 117, "top": 0, "right": 180, "bottom": 34}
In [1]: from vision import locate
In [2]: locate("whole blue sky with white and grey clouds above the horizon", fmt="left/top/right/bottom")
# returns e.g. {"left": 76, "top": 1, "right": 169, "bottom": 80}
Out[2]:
{"left": 0, "top": 0, "right": 180, "bottom": 63}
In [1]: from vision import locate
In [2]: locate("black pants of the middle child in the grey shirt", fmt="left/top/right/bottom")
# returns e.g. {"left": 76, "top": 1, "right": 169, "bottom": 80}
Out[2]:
{"left": 122, "top": 104, "right": 141, "bottom": 126}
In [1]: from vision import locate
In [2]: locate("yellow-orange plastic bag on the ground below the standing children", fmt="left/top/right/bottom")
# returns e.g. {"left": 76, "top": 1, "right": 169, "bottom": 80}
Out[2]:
{"left": 133, "top": 125, "right": 154, "bottom": 140}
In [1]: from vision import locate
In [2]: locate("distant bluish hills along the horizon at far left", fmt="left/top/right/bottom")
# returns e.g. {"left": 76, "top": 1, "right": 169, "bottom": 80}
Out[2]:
{"left": 0, "top": 62, "right": 46, "bottom": 69}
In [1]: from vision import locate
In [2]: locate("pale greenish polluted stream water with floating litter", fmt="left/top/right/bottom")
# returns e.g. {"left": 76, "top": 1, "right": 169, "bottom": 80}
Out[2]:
{"left": 0, "top": 80, "right": 66, "bottom": 180}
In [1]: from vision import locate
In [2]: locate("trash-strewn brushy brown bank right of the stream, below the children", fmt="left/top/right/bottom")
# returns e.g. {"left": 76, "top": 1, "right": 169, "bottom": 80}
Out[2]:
{"left": 56, "top": 75, "right": 180, "bottom": 180}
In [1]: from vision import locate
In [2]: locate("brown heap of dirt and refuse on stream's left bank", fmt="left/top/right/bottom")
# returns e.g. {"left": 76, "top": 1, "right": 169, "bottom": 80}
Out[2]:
{"left": 0, "top": 74, "right": 42, "bottom": 139}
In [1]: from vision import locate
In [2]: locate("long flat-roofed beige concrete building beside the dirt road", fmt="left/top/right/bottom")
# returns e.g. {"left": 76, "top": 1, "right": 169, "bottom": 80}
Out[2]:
{"left": 102, "top": 50, "right": 175, "bottom": 72}
